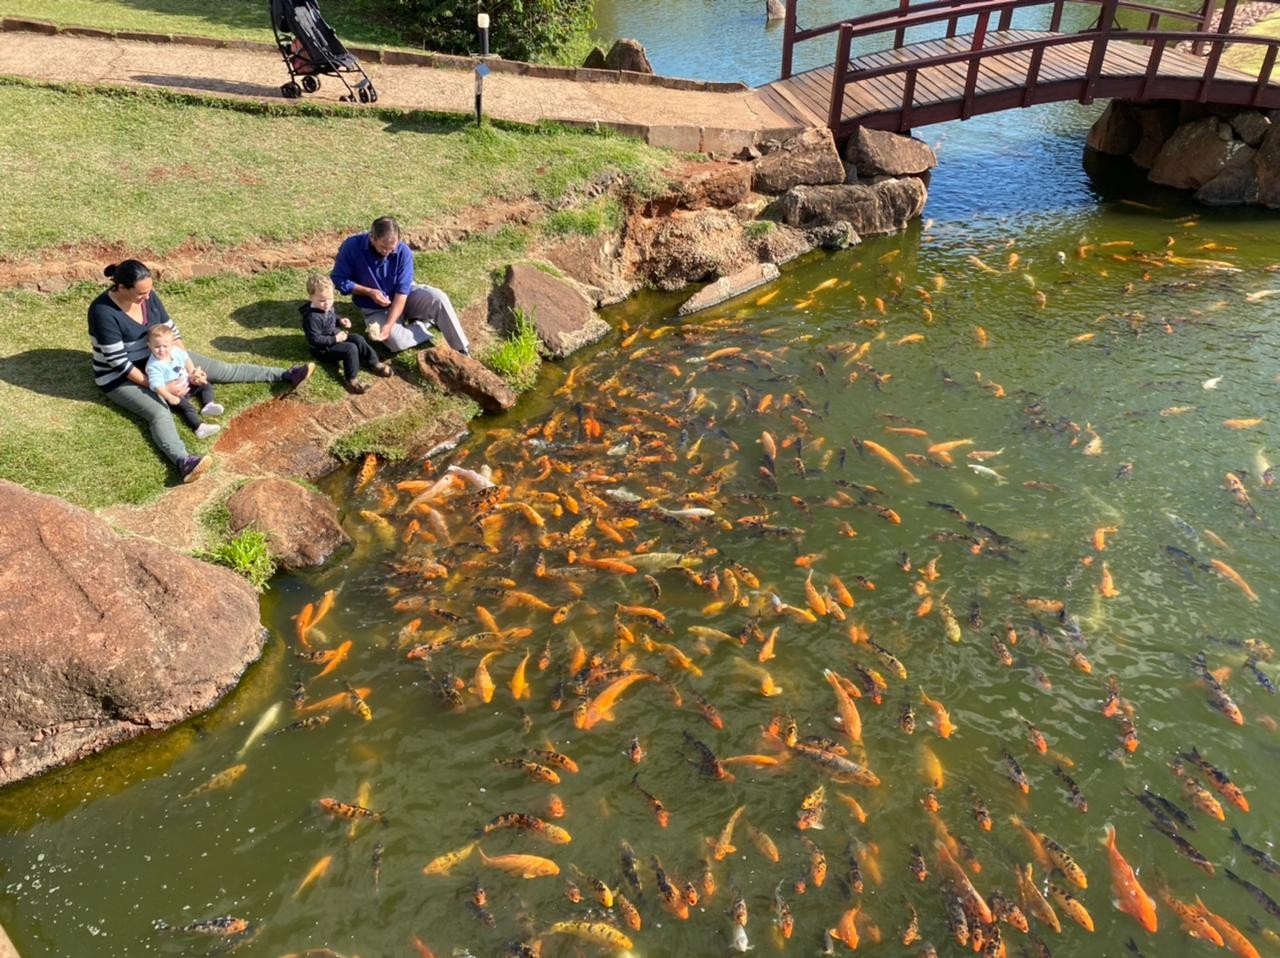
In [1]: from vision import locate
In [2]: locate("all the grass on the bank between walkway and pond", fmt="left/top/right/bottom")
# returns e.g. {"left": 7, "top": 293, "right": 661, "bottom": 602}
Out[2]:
{"left": 0, "top": 81, "right": 669, "bottom": 508}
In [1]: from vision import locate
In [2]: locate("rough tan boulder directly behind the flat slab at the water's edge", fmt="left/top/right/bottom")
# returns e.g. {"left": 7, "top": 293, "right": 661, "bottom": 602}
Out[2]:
{"left": 623, "top": 210, "right": 755, "bottom": 291}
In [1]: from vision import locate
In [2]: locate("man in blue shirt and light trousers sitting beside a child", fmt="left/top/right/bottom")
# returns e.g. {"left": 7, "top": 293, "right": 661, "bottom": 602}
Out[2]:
{"left": 330, "top": 216, "right": 471, "bottom": 353}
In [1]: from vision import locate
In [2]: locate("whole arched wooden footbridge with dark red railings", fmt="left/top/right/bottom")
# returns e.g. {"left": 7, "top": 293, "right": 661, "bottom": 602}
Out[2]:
{"left": 758, "top": 0, "right": 1280, "bottom": 140}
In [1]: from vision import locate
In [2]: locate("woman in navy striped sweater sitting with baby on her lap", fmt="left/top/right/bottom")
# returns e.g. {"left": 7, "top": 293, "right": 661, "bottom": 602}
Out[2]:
{"left": 88, "top": 260, "right": 315, "bottom": 483}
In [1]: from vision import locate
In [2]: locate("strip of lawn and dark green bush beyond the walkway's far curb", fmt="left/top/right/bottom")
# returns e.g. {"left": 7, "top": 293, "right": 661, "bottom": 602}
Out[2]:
{"left": 0, "top": 0, "right": 594, "bottom": 65}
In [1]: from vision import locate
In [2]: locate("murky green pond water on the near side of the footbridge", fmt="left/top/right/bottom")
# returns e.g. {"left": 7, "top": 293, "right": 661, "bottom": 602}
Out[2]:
{"left": 0, "top": 7, "right": 1280, "bottom": 958}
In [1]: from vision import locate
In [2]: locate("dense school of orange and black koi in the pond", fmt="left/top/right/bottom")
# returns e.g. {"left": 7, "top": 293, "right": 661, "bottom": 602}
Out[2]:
{"left": 152, "top": 234, "right": 1280, "bottom": 958}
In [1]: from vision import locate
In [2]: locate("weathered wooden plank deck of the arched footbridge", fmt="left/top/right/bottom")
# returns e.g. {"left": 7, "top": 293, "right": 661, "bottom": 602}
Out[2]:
{"left": 760, "top": 29, "right": 1252, "bottom": 127}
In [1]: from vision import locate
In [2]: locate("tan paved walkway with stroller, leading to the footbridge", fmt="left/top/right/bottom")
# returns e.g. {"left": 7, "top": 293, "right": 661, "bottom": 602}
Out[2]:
{"left": 0, "top": 31, "right": 797, "bottom": 152}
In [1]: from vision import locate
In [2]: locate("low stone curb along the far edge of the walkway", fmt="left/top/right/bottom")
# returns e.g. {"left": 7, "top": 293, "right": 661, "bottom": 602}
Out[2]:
{"left": 0, "top": 17, "right": 750, "bottom": 93}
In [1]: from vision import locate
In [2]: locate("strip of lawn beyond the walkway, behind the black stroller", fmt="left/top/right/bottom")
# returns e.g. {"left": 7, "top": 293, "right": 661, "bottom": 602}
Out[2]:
{"left": 0, "top": 0, "right": 404, "bottom": 46}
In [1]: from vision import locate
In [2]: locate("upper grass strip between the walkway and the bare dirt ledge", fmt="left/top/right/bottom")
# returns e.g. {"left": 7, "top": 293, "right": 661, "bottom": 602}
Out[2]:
{"left": 0, "top": 81, "right": 669, "bottom": 259}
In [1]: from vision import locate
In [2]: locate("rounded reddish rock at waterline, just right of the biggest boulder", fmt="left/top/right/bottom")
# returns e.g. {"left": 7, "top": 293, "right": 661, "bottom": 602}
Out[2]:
{"left": 227, "top": 479, "right": 351, "bottom": 571}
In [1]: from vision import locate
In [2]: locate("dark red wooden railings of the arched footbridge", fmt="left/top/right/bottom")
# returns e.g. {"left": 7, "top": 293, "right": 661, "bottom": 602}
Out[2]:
{"left": 782, "top": 0, "right": 1280, "bottom": 134}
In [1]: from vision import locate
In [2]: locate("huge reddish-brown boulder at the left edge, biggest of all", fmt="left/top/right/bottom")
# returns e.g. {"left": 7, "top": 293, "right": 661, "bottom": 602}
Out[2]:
{"left": 0, "top": 482, "right": 264, "bottom": 785}
